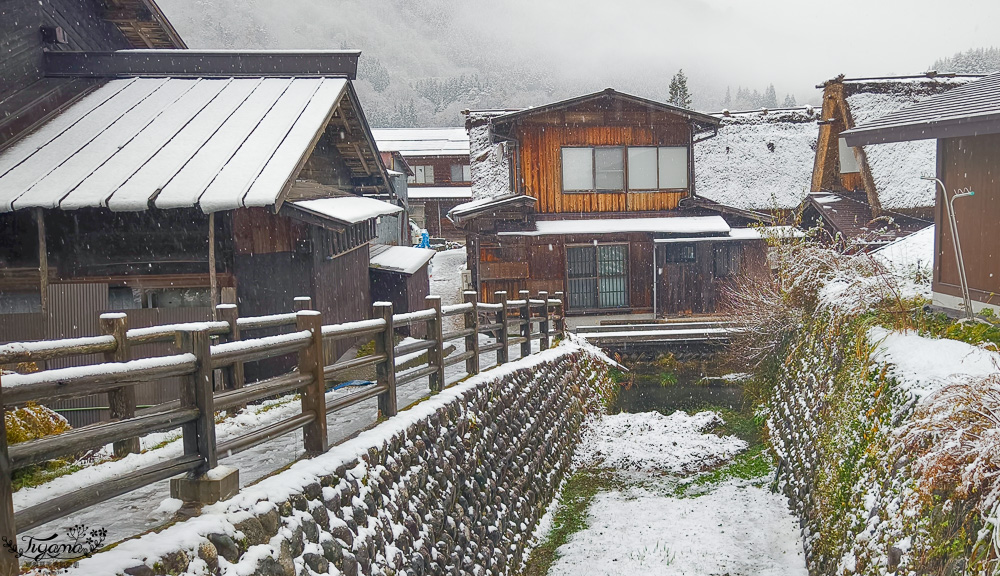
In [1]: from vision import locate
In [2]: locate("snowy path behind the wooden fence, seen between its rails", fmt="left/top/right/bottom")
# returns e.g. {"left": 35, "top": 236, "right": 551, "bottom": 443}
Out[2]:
{"left": 14, "top": 248, "right": 538, "bottom": 543}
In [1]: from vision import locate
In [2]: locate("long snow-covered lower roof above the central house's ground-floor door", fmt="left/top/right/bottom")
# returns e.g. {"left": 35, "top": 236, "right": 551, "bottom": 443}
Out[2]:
{"left": 498, "top": 216, "right": 731, "bottom": 236}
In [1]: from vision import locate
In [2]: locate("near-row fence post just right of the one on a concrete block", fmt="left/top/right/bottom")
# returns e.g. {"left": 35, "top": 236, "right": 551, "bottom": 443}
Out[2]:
{"left": 295, "top": 310, "right": 328, "bottom": 454}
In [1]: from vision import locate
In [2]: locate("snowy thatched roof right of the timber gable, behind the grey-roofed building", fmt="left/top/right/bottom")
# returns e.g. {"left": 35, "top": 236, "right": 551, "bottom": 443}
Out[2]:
{"left": 843, "top": 76, "right": 973, "bottom": 210}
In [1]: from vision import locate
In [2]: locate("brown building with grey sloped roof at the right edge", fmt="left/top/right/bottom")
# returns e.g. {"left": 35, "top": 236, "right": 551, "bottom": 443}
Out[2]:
{"left": 844, "top": 74, "right": 1000, "bottom": 314}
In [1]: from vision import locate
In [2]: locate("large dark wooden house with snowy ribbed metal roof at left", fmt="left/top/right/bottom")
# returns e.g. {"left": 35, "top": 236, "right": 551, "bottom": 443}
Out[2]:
{"left": 0, "top": 0, "right": 402, "bottom": 423}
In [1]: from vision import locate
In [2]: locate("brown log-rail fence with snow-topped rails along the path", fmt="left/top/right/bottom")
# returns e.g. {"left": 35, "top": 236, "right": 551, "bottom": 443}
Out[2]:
{"left": 0, "top": 291, "right": 565, "bottom": 576}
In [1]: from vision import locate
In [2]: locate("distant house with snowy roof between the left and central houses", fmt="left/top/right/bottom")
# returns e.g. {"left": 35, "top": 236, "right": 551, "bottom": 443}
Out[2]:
{"left": 373, "top": 127, "right": 472, "bottom": 240}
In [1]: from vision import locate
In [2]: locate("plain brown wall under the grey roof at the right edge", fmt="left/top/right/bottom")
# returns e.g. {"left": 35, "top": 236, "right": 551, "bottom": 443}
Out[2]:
{"left": 934, "top": 134, "right": 1000, "bottom": 305}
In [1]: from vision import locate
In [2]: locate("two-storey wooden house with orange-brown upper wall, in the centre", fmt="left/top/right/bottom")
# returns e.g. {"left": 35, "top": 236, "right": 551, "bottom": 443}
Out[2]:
{"left": 449, "top": 90, "right": 765, "bottom": 316}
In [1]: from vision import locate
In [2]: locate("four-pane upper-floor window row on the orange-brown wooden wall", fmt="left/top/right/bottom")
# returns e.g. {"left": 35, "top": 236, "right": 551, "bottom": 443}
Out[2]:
{"left": 562, "top": 146, "right": 688, "bottom": 192}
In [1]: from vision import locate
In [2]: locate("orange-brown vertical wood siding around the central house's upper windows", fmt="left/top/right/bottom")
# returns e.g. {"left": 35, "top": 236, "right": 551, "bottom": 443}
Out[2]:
{"left": 518, "top": 121, "right": 691, "bottom": 213}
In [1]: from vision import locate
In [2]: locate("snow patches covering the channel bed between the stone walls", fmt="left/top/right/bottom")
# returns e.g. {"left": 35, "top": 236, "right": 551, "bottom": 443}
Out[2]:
{"left": 549, "top": 412, "right": 807, "bottom": 576}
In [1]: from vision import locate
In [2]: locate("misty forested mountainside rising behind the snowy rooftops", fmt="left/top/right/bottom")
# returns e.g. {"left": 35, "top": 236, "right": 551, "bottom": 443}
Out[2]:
{"left": 154, "top": 0, "right": 997, "bottom": 127}
